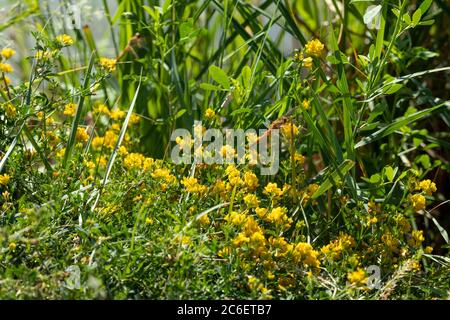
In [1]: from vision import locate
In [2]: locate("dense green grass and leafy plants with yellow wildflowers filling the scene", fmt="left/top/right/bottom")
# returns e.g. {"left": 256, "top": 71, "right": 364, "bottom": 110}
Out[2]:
{"left": 0, "top": 0, "right": 450, "bottom": 299}
